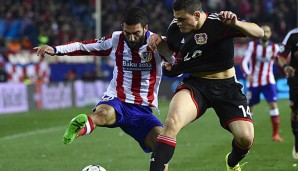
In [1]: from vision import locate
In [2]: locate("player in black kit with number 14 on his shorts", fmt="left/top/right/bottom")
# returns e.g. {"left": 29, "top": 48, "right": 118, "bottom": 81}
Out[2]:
{"left": 148, "top": 0, "right": 264, "bottom": 171}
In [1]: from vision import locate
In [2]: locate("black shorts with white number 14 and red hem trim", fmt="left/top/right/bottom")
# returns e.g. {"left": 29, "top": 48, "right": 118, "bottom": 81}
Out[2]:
{"left": 176, "top": 77, "right": 252, "bottom": 130}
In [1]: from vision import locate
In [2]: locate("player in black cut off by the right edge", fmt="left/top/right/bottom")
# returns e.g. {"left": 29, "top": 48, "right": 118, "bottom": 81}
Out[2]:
{"left": 278, "top": 28, "right": 298, "bottom": 160}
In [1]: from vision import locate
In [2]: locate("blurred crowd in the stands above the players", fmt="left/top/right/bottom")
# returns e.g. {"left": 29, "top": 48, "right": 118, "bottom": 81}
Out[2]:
{"left": 0, "top": 0, "right": 297, "bottom": 51}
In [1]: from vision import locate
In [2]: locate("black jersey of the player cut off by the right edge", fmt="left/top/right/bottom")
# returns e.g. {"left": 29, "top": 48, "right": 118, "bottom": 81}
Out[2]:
{"left": 279, "top": 28, "right": 298, "bottom": 70}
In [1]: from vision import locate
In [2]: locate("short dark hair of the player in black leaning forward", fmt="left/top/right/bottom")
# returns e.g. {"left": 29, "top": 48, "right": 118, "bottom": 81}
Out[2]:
{"left": 173, "top": 0, "right": 202, "bottom": 14}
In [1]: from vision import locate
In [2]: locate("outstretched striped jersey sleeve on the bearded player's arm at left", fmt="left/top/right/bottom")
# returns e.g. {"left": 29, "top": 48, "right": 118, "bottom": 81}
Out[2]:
{"left": 55, "top": 34, "right": 113, "bottom": 56}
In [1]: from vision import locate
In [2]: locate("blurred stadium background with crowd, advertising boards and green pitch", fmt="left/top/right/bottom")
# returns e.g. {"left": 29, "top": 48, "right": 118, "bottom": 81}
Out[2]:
{"left": 0, "top": 0, "right": 298, "bottom": 171}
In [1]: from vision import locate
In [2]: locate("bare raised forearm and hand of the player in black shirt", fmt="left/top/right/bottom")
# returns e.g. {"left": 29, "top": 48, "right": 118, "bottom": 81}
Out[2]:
{"left": 219, "top": 11, "right": 264, "bottom": 38}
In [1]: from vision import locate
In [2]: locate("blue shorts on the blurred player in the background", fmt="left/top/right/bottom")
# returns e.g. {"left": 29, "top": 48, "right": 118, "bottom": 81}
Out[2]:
{"left": 246, "top": 84, "right": 277, "bottom": 106}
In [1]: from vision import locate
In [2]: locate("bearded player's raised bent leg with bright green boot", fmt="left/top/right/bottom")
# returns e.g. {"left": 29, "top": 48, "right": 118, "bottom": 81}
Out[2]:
{"left": 63, "top": 96, "right": 116, "bottom": 144}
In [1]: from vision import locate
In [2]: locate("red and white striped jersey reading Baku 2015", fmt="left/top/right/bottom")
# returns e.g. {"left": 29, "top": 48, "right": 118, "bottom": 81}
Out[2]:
{"left": 56, "top": 31, "right": 174, "bottom": 107}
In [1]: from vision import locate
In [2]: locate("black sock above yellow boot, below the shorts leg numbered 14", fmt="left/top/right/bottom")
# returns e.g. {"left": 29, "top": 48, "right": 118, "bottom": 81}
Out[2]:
{"left": 228, "top": 139, "right": 250, "bottom": 167}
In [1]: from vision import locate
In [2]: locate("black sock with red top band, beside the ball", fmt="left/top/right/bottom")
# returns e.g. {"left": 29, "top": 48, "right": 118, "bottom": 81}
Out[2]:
{"left": 150, "top": 135, "right": 176, "bottom": 171}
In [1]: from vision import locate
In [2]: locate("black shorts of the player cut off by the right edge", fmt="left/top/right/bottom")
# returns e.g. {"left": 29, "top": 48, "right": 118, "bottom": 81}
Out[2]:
{"left": 288, "top": 77, "right": 298, "bottom": 110}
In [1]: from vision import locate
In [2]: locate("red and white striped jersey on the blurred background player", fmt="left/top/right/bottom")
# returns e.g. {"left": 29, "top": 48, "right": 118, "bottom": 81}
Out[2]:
{"left": 241, "top": 40, "right": 279, "bottom": 87}
